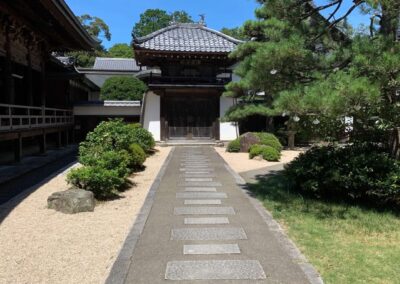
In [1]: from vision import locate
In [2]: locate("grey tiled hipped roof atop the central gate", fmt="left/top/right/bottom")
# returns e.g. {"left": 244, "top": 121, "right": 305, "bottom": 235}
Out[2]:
{"left": 134, "top": 24, "right": 242, "bottom": 53}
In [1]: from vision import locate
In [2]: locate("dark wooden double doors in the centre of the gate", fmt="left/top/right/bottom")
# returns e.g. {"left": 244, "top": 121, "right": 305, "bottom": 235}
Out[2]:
{"left": 163, "top": 94, "right": 219, "bottom": 139}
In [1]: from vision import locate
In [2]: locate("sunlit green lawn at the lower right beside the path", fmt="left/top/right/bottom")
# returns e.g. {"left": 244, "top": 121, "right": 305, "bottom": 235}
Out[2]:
{"left": 249, "top": 171, "right": 400, "bottom": 284}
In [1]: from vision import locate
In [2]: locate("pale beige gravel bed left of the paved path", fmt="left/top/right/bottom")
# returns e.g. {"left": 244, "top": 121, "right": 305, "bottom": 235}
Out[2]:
{"left": 0, "top": 148, "right": 170, "bottom": 284}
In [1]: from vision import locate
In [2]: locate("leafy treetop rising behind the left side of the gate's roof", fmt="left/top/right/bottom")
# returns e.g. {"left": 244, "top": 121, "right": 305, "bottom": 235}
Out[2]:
{"left": 132, "top": 9, "right": 193, "bottom": 38}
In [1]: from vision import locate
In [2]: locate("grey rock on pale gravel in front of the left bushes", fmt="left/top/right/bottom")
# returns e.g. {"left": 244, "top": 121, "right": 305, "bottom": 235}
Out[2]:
{"left": 47, "top": 189, "right": 96, "bottom": 214}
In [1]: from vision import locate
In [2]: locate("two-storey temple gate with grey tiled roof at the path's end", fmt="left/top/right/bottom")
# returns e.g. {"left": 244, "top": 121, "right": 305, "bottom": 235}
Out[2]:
{"left": 133, "top": 23, "right": 241, "bottom": 141}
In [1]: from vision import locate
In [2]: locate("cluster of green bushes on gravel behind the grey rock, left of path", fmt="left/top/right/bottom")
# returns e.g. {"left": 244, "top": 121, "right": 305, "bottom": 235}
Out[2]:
{"left": 67, "top": 119, "right": 155, "bottom": 199}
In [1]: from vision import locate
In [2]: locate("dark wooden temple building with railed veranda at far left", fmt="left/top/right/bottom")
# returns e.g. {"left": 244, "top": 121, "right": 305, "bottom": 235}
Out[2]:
{"left": 0, "top": 0, "right": 99, "bottom": 163}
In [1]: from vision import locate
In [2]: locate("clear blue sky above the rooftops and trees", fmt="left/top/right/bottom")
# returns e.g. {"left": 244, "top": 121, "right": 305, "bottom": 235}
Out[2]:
{"left": 66, "top": 0, "right": 365, "bottom": 48}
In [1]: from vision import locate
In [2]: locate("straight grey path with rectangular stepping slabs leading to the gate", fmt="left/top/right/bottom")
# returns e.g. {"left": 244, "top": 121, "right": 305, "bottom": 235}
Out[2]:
{"left": 107, "top": 147, "right": 318, "bottom": 284}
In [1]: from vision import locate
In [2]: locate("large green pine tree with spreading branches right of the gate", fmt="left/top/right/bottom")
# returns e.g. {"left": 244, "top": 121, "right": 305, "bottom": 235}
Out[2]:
{"left": 225, "top": 0, "right": 400, "bottom": 156}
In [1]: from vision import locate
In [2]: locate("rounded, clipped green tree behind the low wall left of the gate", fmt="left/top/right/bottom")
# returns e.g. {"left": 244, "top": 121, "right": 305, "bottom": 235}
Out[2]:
{"left": 101, "top": 76, "right": 148, "bottom": 101}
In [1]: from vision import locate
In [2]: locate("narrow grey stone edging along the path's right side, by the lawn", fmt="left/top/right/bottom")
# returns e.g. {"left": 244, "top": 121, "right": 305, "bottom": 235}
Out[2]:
{"left": 217, "top": 152, "right": 324, "bottom": 284}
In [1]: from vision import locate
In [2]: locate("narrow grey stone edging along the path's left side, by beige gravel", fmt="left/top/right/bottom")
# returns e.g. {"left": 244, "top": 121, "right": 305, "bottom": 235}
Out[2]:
{"left": 105, "top": 147, "right": 175, "bottom": 284}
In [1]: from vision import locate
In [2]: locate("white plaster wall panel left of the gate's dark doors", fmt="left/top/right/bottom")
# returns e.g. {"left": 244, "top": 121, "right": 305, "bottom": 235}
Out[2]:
{"left": 142, "top": 92, "right": 161, "bottom": 141}
